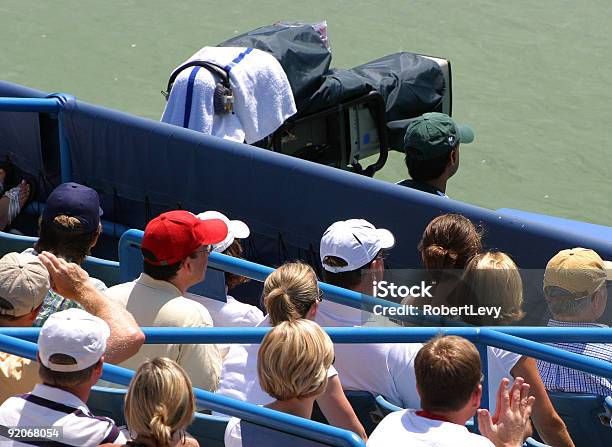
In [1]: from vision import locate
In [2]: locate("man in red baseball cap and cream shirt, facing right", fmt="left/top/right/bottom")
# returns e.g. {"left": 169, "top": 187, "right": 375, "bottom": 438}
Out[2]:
{"left": 107, "top": 210, "right": 227, "bottom": 391}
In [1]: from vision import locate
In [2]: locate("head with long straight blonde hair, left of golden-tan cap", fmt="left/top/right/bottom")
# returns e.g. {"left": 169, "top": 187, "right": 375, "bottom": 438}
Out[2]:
{"left": 459, "top": 252, "right": 524, "bottom": 326}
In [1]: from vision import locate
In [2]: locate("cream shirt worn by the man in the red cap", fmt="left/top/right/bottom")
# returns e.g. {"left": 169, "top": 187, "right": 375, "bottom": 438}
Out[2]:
{"left": 106, "top": 273, "right": 221, "bottom": 391}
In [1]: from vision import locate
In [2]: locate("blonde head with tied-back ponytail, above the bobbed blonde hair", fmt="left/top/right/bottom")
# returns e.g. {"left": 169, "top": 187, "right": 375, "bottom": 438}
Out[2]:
{"left": 263, "top": 262, "right": 319, "bottom": 326}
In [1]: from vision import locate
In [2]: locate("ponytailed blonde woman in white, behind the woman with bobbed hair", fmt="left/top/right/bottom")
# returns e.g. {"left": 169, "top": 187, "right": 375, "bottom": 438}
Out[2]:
{"left": 217, "top": 262, "right": 366, "bottom": 439}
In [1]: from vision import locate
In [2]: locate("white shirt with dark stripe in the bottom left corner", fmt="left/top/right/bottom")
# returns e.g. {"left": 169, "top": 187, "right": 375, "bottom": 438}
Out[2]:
{"left": 0, "top": 384, "right": 127, "bottom": 447}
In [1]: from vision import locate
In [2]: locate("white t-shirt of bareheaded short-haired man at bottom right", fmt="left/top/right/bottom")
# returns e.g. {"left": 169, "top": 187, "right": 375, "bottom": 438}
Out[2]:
{"left": 368, "top": 410, "right": 493, "bottom": 447}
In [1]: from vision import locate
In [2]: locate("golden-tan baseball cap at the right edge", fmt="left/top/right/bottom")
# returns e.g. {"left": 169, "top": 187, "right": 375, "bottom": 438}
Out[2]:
{"left": 544, "top": 248, "right": 612, "bottom": 299}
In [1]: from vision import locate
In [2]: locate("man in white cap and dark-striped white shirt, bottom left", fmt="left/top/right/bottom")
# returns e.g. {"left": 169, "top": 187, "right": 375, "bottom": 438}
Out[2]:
{"left": 0, "top": 308, "right": 127, "bottom": 447}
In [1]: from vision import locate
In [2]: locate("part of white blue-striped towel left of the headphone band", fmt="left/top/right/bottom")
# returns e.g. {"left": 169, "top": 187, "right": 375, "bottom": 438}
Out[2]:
{"left": 161, "top": 60, "right": 244, "bottom": 143}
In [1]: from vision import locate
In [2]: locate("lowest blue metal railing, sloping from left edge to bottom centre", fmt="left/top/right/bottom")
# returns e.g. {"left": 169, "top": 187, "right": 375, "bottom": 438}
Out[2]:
{"left": 0, "top": 334, "right": 365, "bottom": 447}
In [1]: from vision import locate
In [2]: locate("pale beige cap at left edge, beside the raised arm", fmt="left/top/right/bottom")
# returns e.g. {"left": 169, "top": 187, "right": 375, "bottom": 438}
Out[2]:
{"left": 0, "top": 253, "right": 50, "bottom": 317}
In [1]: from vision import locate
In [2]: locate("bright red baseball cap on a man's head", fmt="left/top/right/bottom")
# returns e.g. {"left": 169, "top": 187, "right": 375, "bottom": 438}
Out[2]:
{"left": 141, "top": 210, "right": 227, "bottom": 265}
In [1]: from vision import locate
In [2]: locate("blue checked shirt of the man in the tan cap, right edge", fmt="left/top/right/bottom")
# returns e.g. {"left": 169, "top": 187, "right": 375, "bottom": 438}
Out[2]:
{"left": 537, "top": 320, "right": 612, "bottom": 396}
